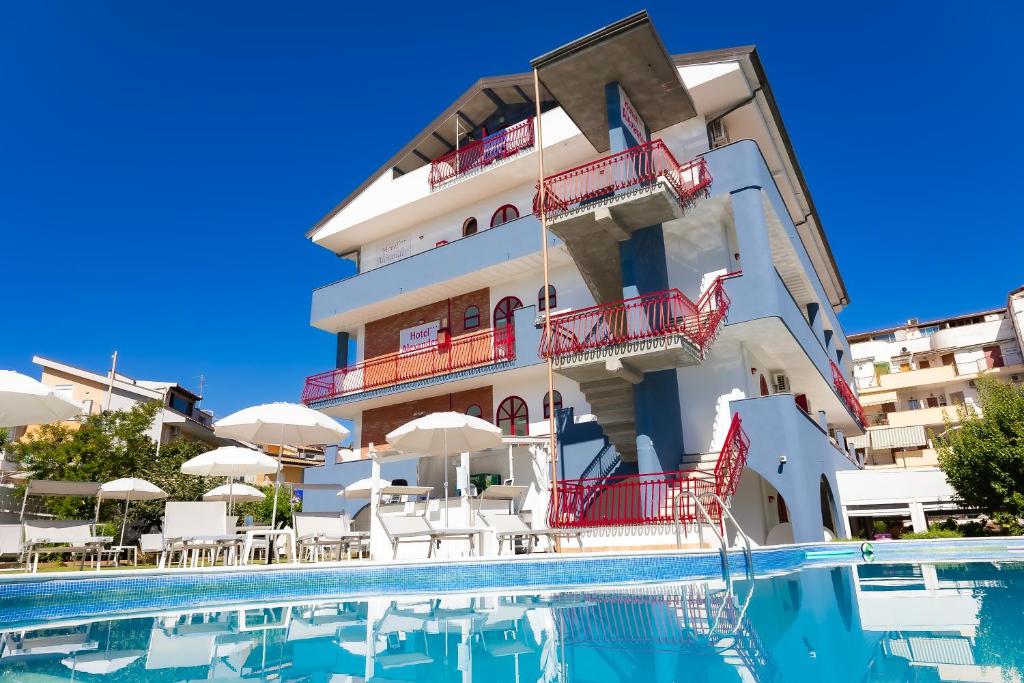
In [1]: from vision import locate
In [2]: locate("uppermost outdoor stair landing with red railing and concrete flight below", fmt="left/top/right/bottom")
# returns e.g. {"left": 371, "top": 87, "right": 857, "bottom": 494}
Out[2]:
{"left": 534, "top": 140, "right": 711, "bottom": 301}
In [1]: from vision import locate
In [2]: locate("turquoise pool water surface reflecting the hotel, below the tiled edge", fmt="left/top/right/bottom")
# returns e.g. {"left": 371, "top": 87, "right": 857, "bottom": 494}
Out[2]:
{"left": 0, "top": 563, "right": 1024, "bottom": 683}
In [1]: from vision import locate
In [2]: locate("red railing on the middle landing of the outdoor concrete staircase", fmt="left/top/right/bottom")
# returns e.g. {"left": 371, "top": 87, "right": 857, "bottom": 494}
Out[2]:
{"left": 540, "top": 273, "right": 738, "bottom": 358}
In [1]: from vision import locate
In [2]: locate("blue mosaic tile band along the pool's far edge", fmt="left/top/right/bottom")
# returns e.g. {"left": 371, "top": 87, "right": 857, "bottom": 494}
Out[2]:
{"left": 0, "top": 539, "right": 1024, "bottom": 629}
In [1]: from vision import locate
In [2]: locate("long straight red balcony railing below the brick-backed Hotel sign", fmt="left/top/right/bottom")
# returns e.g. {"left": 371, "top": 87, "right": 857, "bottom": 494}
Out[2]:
{"left": 302, "top": 325, "right": 515, "bottom": 403}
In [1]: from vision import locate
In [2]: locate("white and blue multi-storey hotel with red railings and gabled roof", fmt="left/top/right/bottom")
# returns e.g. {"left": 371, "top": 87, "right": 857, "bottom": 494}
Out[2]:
{"left": 303, "top": 12, "right": 862, "bottom": 543}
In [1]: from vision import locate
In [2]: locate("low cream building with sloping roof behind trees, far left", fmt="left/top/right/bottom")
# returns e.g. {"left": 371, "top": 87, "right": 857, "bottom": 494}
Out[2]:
{"left": 32, "top": 355, "right": 233, "bottom": 446}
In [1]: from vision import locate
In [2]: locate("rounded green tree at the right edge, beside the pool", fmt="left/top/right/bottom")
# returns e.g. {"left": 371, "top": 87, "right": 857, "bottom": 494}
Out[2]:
{"left": 937, "top": 377, "right": 1024, "bottom": 530}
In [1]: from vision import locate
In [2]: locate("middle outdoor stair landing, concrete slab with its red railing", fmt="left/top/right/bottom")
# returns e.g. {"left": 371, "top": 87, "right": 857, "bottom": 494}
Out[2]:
{"left": 540, "top": 275, "right": 731, "bottom": 383}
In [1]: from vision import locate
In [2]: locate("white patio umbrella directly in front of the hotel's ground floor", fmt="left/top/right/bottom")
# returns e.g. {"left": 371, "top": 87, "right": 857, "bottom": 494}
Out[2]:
{"left": 385, "top": 413, "right": 502, "bottom": 525}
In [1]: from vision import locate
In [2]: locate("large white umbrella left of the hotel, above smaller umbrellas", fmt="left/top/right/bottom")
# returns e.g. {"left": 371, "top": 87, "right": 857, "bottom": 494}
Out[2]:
{"left": 213, "top": 402, "right": 348, "bottom": 526}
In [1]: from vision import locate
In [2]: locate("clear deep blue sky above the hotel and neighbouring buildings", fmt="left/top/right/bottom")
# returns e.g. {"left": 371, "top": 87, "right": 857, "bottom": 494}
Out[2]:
{"left": 0, "top": 0, "right": 1024, "bottom": 415}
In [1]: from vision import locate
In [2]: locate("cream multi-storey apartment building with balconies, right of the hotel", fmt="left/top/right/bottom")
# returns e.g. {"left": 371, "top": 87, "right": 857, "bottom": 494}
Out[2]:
{"left": 840, "top": 299, "right": 1024, "bottom": 535}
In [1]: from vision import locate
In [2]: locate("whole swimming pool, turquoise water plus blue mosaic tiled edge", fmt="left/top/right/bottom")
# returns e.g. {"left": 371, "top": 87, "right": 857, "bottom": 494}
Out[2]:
{"left": 0, "top": 542, "right": 1024, "bottom": 683}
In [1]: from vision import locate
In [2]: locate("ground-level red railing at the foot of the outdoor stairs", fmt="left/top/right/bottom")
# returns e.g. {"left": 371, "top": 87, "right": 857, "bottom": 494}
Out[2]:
{"left": 548, "top": 415, "right": 751, "bottom": 527}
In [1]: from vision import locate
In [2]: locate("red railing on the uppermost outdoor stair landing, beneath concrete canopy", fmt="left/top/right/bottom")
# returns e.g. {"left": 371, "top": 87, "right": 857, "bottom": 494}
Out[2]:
{"left": 534, "top": 140, "right": 712, "bottom": 218}
